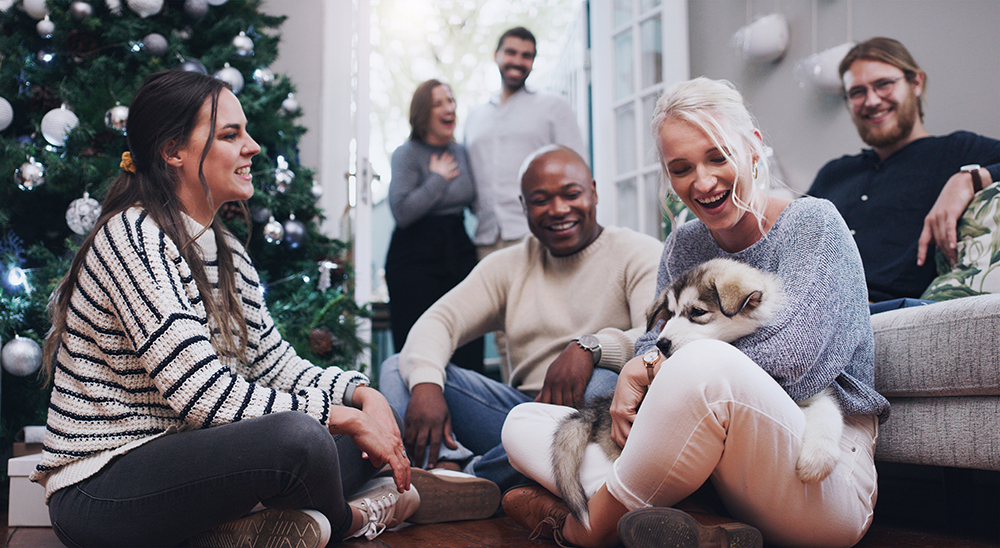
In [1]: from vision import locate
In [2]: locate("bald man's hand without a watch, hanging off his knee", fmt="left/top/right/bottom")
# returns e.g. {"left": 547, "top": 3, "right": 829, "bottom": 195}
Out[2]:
{"left": 403, "top": 383, "right": 458, "bottom": 468}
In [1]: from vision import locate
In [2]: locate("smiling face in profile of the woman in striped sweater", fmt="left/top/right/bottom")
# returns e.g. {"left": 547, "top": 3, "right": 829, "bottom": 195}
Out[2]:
{"left": 167, "top": 89, "right": 260, "bottom": 225}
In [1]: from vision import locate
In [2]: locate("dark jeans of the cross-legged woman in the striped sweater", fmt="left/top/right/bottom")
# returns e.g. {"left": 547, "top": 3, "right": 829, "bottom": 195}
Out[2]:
{"left": 49, "top": 412, "right": 377, "bottom": 547}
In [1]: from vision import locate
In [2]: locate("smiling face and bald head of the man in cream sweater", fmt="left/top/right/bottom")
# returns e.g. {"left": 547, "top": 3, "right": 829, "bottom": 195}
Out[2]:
{"left": 521, "top": 149, "right": 602, "bottom": 257}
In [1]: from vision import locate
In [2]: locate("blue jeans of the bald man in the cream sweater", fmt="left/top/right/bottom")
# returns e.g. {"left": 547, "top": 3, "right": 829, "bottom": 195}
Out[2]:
{"left": 378, "top": 354, "right": 618, "bottom": 492}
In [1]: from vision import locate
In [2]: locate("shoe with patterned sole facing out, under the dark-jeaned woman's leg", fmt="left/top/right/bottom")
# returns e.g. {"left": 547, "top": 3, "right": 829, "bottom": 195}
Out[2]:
{"left": 182, "top": 508, "right": 331, "bottom": 548}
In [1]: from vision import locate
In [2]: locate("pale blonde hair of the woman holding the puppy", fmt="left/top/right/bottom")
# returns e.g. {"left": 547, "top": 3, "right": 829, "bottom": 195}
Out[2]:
{"left": 652, "top": 77, "right": 771, "bottom": 238}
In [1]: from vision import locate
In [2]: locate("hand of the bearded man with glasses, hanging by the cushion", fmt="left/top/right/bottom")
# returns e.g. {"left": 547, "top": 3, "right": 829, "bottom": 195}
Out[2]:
{"left": 917, "top": 169, "right": 993, "bottom": 265}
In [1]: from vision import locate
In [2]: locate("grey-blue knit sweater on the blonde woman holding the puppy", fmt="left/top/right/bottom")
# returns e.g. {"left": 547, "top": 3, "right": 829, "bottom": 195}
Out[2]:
{"left": 636, "top": 198, "right": 889, "bottom": 422}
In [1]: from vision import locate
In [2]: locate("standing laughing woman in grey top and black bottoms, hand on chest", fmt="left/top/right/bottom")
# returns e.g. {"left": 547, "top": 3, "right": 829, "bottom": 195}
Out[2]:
{"left": 385, "top": 80, "right": 483, "bottom": 373}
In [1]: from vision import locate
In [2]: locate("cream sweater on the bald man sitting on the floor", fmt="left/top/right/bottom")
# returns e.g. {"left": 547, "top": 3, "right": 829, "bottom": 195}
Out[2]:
{"left": 399, "top": 227, "right": 663, "bottom": 393}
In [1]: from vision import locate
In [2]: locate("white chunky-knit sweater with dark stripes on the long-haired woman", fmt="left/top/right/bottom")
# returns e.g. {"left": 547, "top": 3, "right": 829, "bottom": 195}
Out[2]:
{"left": 31, "top": 208, "right": 368, "bottom": 496}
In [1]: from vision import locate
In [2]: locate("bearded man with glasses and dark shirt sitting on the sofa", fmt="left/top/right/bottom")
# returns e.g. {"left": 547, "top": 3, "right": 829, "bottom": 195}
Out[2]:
{"left": 809, "top": 38, "right": 1000, "bottom": 302}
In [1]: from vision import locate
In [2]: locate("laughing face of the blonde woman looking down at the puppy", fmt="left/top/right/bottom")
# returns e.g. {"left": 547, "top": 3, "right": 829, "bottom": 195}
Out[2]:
{"left": 658, "top": 118, "right": 761, "bottom": 252}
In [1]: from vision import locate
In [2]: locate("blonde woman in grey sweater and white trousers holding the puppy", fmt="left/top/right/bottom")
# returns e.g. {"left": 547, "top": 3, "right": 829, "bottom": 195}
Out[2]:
{"left": 504, "top": 78, "right": 889, "bottom": 548}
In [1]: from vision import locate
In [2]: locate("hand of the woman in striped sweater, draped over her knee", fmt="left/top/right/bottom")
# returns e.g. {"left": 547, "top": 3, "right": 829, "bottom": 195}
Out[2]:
{"left": 328, "top": 396, "right": 410, "bottom": 493}
